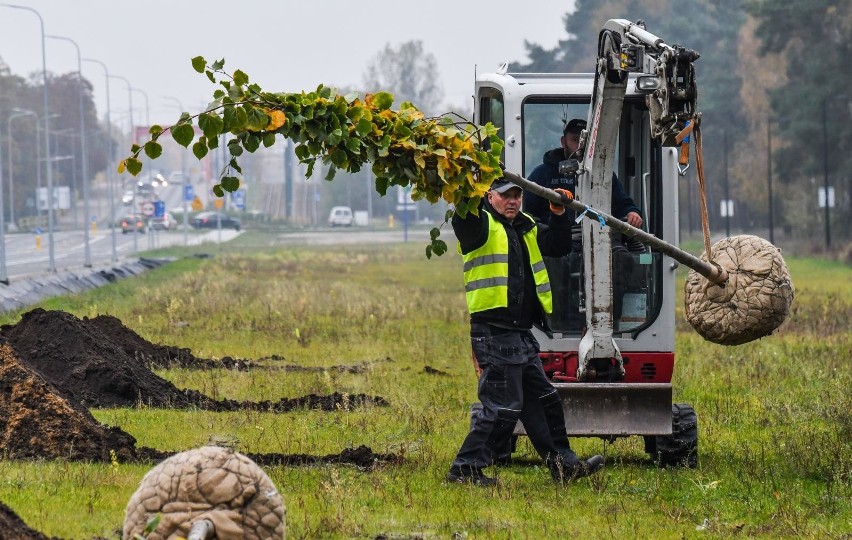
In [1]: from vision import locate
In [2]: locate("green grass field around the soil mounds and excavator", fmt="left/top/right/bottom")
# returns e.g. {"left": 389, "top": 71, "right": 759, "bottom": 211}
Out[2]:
{"left": 0, "top": 235, "right": 852, "bottom": 539}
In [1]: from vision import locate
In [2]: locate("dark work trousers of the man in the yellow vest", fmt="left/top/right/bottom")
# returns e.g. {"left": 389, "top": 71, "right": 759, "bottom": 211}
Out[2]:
{"left": 450, "top": 325, "right": 578, "bottom": 474}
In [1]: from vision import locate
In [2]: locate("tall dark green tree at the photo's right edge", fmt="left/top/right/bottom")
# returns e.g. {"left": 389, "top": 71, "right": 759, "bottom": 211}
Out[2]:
{"left": 748, "top": 0, "right": 852, "bottom": 245}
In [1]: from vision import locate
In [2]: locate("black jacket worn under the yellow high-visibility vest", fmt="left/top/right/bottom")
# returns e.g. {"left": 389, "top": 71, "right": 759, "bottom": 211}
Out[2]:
{"left": 452, "top": 195, "right": 573, "bottom": 330}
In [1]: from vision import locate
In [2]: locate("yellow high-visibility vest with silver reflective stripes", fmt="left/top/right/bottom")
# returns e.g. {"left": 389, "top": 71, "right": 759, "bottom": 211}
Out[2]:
{"left": 459, "top": 209, "right": 553, "bottom": 313}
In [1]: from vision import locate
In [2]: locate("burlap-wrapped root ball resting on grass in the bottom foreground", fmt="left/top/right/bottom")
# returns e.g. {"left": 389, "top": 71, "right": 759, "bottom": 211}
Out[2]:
{"left": 123, "top": 446, "right": 286, "bottom": 540}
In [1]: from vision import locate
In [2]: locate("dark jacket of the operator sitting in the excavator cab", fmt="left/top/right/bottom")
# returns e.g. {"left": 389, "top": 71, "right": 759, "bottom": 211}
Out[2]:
{"left": 524, "top": 147, "right": 642, "bottom": 223}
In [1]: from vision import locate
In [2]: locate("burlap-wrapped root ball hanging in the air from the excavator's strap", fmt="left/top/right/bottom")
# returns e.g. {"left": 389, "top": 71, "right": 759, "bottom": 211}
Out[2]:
{"left": 684, "top": 235, "right": 794, "bottom": 345}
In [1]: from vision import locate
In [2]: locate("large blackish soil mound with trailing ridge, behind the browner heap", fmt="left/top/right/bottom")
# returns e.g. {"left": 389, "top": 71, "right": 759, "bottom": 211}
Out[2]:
{"left": 0, "top": 308, "right": 388, "bottom": 412}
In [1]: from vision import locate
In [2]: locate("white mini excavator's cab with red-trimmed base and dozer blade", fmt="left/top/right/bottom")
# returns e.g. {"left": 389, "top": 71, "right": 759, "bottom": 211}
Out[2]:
{"left": 475, "top": 63, "right": 695, "bottom": 461}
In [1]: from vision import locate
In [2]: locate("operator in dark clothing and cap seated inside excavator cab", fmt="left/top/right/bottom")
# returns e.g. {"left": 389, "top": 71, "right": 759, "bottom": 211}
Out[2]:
{"left": 524, "top": 118, "right": 642, "bottom": 227}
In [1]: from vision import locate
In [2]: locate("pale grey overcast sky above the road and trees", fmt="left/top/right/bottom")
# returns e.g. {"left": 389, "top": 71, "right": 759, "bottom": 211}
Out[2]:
{"left": 0, "top": 0, "right": 574, "bottom": 125}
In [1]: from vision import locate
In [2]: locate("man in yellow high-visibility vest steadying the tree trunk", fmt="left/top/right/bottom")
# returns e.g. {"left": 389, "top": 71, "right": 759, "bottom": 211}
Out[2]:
{"left": 447, "top": 180, "right": 604, "bottom": 486}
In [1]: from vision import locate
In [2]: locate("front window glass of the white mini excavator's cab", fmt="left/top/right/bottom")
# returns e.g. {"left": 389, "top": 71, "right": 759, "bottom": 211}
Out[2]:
{"left": 520, "top": 96, "right": 662, "bottom": 337}
